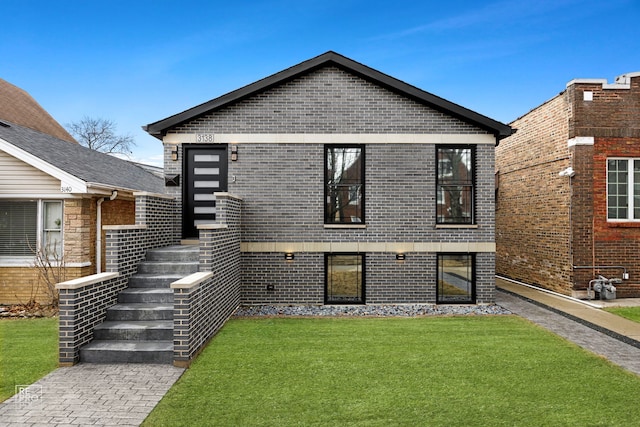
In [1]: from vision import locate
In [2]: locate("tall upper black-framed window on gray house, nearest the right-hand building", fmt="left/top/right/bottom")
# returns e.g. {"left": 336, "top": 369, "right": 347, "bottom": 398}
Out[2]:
{"left": 436, "top": 146, "right": 475, "bottom": 224}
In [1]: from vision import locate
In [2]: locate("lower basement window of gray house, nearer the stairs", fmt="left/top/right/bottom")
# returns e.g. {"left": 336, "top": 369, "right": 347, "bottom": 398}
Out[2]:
{"left": 325, "top": 254, "right": 365, "bottom": 304}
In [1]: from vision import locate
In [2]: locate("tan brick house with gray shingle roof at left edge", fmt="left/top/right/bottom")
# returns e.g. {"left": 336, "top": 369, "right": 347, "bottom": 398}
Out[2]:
{"left": 0, "top": 80, "right": 164, "bottom": 304}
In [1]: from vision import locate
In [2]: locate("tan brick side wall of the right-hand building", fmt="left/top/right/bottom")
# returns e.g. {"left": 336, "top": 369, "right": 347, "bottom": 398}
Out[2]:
{"left": 496, "top": 94, "right": 572, "bottom": 294}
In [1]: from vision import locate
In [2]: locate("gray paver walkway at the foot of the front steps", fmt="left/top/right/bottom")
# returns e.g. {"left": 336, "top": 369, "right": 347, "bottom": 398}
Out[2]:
{"left": 0, "top": 363, "right": 184, "bottom": 427}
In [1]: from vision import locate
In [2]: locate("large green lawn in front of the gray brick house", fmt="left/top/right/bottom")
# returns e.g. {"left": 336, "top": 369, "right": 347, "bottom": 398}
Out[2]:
{"left": 144, "top": 316, "right": 640, "bottom": 426}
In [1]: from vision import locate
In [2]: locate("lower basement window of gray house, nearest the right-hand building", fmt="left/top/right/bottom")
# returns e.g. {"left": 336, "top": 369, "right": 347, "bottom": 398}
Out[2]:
{"left": 436, "top": 254, "right": 476, "bottom": 304}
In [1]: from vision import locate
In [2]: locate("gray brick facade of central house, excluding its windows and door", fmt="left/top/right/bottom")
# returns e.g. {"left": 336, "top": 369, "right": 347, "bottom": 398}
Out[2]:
{"left": 147, "top": 54, "right": 511, "bottom": 304}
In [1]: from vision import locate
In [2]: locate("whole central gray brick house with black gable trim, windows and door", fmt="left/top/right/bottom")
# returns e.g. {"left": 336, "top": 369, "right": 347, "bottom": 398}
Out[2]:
{"left": 144, "top": 52, "right": 511, "bottom": 304}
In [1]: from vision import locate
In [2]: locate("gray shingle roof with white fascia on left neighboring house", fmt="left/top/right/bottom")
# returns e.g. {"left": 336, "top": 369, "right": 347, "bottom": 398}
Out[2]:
{"left": 0, "top": 121, "right": 164, "bottom": 194}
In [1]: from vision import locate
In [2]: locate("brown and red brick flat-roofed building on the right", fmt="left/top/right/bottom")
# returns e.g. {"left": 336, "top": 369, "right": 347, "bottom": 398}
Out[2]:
{"left": 496, "top": 73, "right": 640, "bottom": 297}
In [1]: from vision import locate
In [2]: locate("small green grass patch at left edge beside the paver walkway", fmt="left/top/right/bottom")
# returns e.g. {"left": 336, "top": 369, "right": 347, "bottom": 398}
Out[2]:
{"left": 0, "top": 318, "right": 58, "bottom": 402}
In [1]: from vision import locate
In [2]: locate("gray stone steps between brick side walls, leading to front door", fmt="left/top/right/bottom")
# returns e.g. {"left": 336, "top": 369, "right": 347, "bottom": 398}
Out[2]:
{"left": 80, "top": 245, "right": 199, "bottom": 364}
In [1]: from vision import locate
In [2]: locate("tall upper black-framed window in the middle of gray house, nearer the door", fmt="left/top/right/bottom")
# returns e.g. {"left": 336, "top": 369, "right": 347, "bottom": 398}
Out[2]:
{"left": 324, "top": 145, "right": 364, "bottom": 224}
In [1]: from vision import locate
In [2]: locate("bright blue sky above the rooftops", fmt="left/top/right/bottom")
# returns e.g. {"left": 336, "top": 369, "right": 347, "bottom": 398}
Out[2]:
{"left": 0, "top": 0, "right": 640, "bottom": 165}
